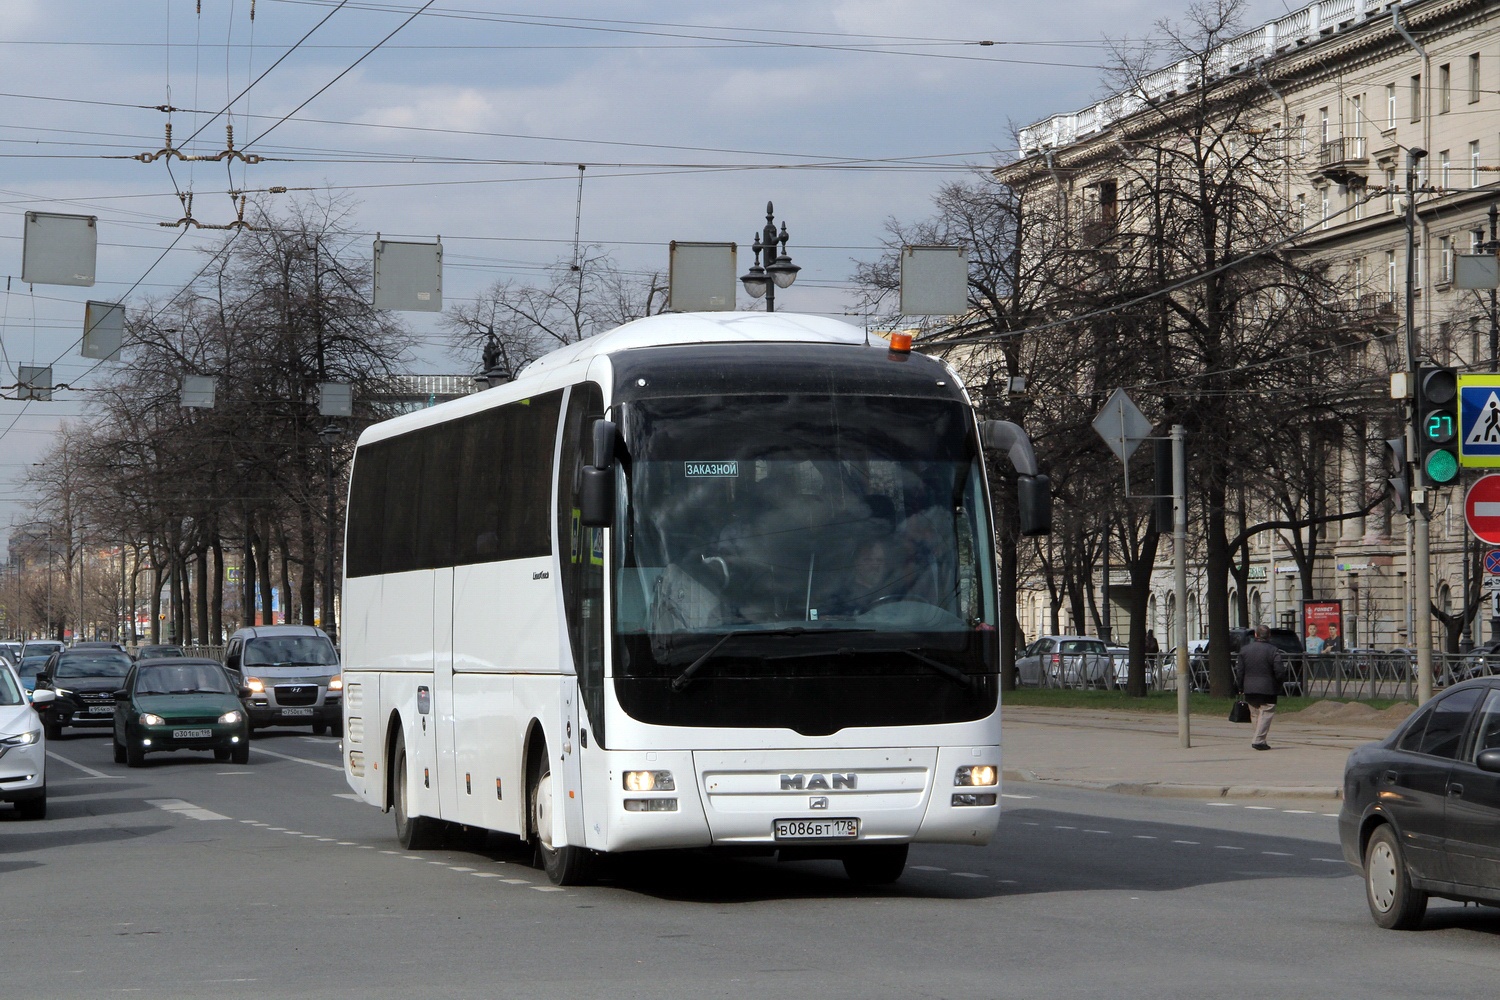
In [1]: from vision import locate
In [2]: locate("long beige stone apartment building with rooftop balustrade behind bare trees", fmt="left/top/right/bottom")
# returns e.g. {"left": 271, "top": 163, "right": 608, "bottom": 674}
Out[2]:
{"left": 996, "top": 0, "right": 1500, "bottom": 648}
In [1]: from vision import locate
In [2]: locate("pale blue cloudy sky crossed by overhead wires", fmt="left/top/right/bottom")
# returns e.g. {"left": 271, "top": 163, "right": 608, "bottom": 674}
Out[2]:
{"left": 0, "top": 0, "right": 1302, "bottom": 544}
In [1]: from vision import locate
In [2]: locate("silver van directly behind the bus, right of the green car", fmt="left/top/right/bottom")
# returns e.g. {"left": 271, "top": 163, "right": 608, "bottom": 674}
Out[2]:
{"left": 224, "top": 625, "right": 344, "bottom": 736}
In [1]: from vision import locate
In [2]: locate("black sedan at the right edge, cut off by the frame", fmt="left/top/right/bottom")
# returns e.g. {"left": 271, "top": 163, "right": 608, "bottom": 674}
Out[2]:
{"left": 1338, "top": 678, "right": 1500, "bottom": 930}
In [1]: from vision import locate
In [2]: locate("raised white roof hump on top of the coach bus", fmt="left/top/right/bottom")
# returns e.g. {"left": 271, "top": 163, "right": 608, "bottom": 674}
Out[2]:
{"left": 519, "top": 312, "right": 885, "bottom": 378}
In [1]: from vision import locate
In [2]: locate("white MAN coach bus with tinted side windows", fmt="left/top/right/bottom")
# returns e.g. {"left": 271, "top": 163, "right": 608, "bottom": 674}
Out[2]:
{"left": 342, "top": 313, "right": 1050, "bottom": 885}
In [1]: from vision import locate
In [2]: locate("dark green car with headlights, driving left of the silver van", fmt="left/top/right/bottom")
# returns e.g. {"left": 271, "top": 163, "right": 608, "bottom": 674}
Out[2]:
{"left": 114, "top": 657, "right": 251, "bottom": 768}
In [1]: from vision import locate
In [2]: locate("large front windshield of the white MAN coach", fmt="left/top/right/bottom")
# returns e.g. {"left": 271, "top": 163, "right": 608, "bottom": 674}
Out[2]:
{"left": 614, "top": 394, "right": 996, "bottom": 731}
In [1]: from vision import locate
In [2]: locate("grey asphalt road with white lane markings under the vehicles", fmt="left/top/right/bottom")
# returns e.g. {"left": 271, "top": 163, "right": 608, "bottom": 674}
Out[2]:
{"left": 0, "top": 730, "right": 1500, "bottom": 1000}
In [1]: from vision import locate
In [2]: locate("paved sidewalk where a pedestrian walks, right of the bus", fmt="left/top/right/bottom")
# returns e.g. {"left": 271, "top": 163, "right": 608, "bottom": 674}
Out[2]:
{"left": 1001, "top": 706, "right": 1391, "bottom": 799}
